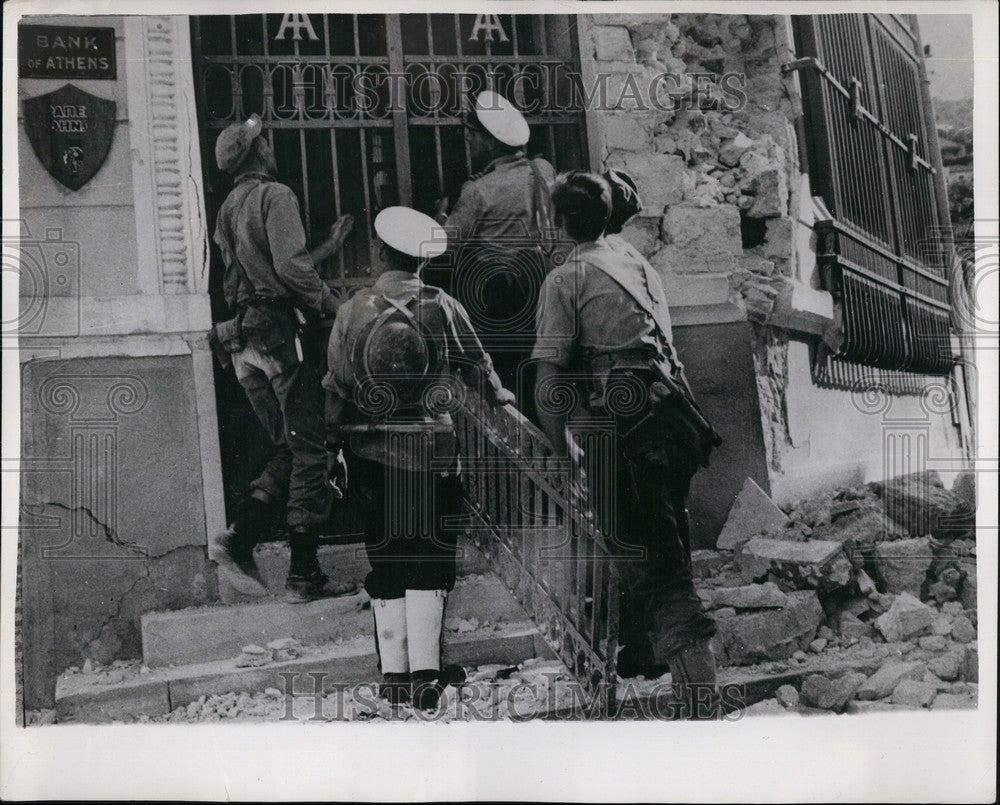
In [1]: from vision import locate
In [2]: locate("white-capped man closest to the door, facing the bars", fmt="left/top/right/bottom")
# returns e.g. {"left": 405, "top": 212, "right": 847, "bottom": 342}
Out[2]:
{"left": 430, "top": 91, "right": 555, "bottom": 398}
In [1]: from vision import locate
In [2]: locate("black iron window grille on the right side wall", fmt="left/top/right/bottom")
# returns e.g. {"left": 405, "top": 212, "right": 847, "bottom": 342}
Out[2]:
{"left": 794, "top": 14, "right": 954, "bottom": 374}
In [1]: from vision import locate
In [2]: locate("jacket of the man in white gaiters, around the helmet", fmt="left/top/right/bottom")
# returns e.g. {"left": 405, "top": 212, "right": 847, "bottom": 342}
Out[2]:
{"left": 323, "top": 271, "right": 503, "bottom": 470}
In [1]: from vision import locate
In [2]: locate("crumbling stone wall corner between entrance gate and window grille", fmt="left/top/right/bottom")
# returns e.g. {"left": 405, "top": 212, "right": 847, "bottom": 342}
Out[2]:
{"left": 585, "top": 14, "right": 961, "bottom": 520}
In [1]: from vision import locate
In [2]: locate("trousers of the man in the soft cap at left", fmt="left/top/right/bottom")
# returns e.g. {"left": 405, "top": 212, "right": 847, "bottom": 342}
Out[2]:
{"left": 233, "top": 343, "right": 331, "bottom": 527}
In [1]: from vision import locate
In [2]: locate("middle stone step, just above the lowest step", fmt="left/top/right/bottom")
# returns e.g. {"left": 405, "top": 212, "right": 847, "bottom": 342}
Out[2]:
{"left": 141, "top": 575, "right": 528, "bottom": 668}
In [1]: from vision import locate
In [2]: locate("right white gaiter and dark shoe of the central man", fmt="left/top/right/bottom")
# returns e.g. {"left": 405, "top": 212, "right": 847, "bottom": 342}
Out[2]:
{"left": 406, "top": 590, "right": 450, "bottom": 710}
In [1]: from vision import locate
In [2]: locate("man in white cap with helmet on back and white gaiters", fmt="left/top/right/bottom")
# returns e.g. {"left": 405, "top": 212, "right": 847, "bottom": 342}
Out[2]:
{"left": 323, "top": 207, "right": 514, "bottom": 709}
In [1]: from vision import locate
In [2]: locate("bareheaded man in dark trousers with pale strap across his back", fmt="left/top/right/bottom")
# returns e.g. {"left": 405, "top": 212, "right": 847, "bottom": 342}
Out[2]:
{"left": 533, "top": 172, "right": 718, "bottom": 715}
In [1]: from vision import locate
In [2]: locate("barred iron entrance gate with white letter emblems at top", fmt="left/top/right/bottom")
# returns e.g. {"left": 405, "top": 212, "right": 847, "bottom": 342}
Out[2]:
{"left": 192, "top": 14, "right": 587, "bottom": 304}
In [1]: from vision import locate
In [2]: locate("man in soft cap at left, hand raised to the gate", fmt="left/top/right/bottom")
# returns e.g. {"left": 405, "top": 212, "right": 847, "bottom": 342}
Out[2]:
{"left": 209, "top": 115, "right": 356, "bottom": 603}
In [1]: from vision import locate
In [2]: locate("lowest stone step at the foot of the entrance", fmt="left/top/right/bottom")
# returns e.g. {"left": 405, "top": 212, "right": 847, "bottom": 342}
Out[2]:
{"left": 56, "top": 621, "right": 551, "bottom": 723}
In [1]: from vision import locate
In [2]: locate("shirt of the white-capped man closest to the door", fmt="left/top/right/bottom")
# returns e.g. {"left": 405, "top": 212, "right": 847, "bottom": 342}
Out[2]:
{"left": 445, "top": 151, "right": 556, "bottom": 243}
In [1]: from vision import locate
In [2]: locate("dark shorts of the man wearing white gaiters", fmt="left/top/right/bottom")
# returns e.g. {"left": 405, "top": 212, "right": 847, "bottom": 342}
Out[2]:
{"left": 347, "top": 453, "right": 462, "bottom": 598}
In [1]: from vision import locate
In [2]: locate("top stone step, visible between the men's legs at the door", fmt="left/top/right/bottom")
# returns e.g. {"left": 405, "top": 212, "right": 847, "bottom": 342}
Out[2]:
{"left": 219, "top": 540, "right": 490, "bottom": 604}
